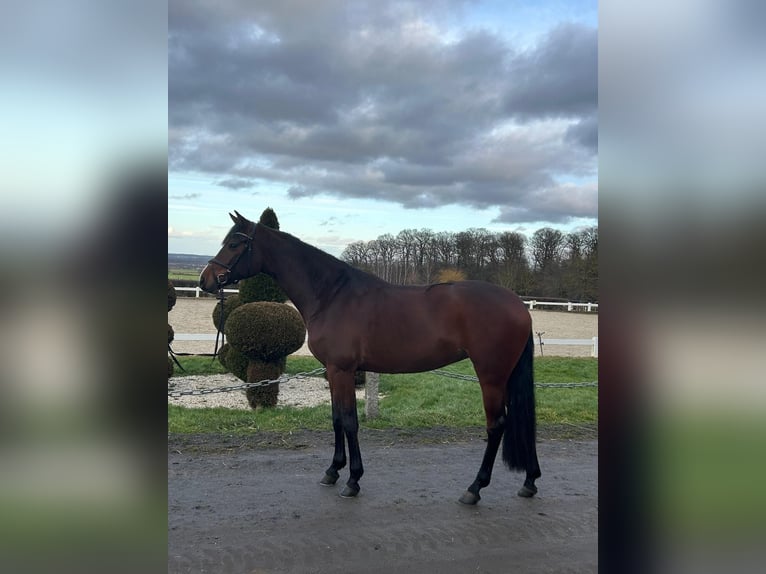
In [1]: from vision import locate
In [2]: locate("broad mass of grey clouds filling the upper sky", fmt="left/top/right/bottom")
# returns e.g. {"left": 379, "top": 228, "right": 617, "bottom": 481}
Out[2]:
{"left": 168, "top": 0, "right": 598, "bottom": 227}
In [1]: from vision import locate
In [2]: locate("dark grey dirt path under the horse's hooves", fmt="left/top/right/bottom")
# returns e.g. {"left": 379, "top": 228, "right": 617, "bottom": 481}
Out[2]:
{"left": 168, "top": 430, "right": 598, "bottom": 574}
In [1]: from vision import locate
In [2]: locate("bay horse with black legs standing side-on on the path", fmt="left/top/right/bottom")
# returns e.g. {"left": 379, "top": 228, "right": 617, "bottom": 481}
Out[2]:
{"left": 199, "top": 211, "right": 541, "bottom": 504}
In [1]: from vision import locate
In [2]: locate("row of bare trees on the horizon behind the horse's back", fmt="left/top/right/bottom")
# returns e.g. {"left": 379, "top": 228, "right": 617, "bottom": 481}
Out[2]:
{"left": 341, "top": 227, "right": 598, "bottom": 302}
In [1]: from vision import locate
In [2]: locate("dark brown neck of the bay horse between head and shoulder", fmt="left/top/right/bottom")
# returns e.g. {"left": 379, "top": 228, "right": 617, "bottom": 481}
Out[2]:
{"left": 263, "top": 226, "right": 339, "bottom": 323}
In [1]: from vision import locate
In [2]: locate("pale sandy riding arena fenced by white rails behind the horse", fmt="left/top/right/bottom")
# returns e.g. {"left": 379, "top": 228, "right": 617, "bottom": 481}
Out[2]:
{"left": 168, "top": 297, "right": 598, "bottom": 357}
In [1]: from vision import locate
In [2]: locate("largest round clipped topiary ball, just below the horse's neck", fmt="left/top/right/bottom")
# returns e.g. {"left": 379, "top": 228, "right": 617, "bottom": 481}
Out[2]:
{"left": 225, "top": 301, "right": 306, "bottom": 361}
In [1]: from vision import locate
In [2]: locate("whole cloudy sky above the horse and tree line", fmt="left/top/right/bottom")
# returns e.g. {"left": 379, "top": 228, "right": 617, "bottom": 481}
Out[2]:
{"left": 168, "top": 0, "right": 598, "bottom": 255}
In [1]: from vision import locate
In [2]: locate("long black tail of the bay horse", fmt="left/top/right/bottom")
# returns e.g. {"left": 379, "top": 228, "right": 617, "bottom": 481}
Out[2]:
{"left": 503, "top": 332, "right": 540, "bottom": 476}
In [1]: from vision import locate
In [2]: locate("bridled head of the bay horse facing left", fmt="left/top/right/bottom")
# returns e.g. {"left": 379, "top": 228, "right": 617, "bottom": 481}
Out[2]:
{"left": 199, "top": 211, "right": 261, "bottom": 293}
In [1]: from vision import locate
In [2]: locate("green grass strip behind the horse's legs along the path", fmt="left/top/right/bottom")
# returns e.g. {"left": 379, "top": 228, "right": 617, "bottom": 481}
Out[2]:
{"left": 168, "top": 356, "right": 598, "bottom": 434}
